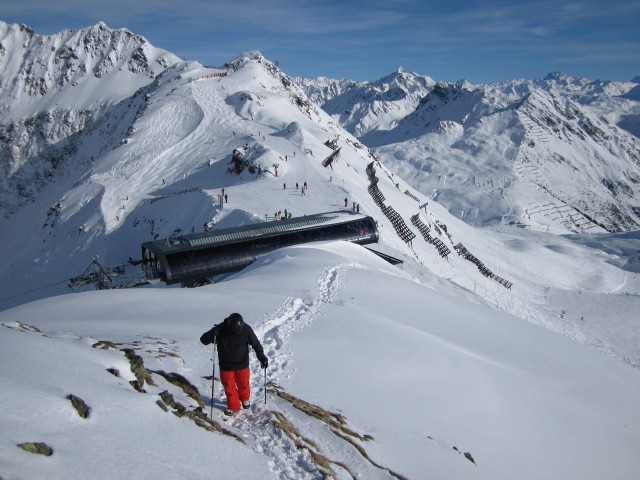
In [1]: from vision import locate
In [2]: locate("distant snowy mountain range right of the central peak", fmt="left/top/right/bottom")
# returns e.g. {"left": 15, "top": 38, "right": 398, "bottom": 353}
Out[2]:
{"left": 299, "top": 70, "right": 640, "bottom": 233}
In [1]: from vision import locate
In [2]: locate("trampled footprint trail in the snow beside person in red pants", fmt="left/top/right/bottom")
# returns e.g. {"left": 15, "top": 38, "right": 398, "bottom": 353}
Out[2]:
{"left": 212, "top": 264, "right": 403, "bottom": 480}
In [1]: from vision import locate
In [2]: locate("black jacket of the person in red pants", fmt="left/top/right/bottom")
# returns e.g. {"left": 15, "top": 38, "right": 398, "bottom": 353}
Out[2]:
{"left": 200, "top": 322, "right": 267, "bottom": 372}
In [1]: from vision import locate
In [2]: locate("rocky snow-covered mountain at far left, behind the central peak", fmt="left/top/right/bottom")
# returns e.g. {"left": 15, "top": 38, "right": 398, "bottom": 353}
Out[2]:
{"left": 0, "top": 22, "right": 179, "bottom": 216}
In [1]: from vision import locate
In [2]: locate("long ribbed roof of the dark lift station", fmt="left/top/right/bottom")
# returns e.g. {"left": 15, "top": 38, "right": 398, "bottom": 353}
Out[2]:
{"left": 142, "top": 210, "right": 366, "bottom": 254}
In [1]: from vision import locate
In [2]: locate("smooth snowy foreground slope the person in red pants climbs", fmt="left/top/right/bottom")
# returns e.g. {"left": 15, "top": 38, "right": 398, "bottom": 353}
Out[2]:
{"left": 0, "top": 243, "right": 640, "bottom": 480}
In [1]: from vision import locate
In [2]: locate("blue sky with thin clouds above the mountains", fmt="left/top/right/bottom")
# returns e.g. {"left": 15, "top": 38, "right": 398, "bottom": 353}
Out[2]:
{"left": 0, "top": 0, "right": 640, "bottom": 83}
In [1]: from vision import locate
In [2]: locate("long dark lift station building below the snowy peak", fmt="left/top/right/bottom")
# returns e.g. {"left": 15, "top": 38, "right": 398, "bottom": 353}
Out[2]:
{"left": 142, "top": 211, "right": 379, "bottom": 286}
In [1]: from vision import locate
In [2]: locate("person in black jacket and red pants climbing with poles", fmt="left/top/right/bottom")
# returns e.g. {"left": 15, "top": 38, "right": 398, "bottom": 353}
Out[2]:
{"left": 200, "top": 313, "right": 269, "bottom": 416}
